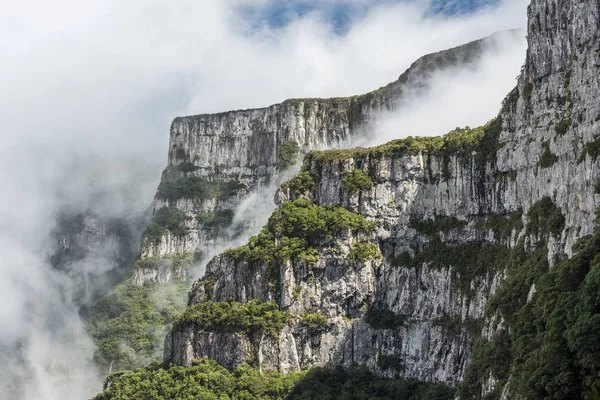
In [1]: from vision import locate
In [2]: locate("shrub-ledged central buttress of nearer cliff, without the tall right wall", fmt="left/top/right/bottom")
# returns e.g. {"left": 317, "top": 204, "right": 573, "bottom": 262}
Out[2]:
{"left": 165, "top": 121, "right": 510, "bottom": 385}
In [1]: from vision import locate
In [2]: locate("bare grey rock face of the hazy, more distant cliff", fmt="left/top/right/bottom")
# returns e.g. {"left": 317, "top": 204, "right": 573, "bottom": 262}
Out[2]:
{"left": 134, "top": 31, "right": 522, "bottom": 285}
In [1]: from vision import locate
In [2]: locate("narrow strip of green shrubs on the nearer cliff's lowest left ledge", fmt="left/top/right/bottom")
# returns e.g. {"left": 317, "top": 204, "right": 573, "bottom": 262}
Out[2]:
{"left": 175, "top": 300, "right": 291, "bottom": 337}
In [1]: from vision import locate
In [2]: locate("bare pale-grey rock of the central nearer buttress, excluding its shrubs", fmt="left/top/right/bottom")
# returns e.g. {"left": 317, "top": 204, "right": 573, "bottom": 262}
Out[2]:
{"left": 166, "top": 148, "right": 506, "bottom": 385}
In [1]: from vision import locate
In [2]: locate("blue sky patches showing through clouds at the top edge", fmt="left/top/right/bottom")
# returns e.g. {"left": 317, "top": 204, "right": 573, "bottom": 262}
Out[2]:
{"left": 240, "top": 0, "right": 499, "bottom": 33}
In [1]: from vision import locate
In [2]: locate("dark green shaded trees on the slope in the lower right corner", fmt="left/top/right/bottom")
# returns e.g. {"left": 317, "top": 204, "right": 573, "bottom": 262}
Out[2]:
{"left": 459, "top": 198, "right": 600, "bottom": 400}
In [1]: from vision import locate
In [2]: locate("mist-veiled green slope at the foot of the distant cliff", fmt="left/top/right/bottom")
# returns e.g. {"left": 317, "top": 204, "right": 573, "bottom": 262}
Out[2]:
{"left": 86, "top": 281, "right": 189, "bottom": 372}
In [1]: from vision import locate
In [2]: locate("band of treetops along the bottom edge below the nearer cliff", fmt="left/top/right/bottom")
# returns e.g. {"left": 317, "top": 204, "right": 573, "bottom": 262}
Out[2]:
{"left": 95, "top": 359, "right": 454, "bottom": 400}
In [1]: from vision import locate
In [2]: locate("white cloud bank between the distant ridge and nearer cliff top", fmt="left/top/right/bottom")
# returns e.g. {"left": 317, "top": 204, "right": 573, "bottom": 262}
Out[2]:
{"left": 366, "top": 31, "right": 527, "bottom": 145}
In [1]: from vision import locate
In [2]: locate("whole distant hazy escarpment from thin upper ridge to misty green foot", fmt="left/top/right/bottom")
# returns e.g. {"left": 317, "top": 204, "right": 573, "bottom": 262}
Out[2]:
{"left": 88, "top": 32, "right": 521, "bottom": 372}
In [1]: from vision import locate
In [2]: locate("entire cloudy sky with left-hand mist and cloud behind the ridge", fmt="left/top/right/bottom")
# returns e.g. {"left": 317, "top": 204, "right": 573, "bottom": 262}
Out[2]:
{"left": 0, "top": 0, "right": 527, "bottom": 400}
